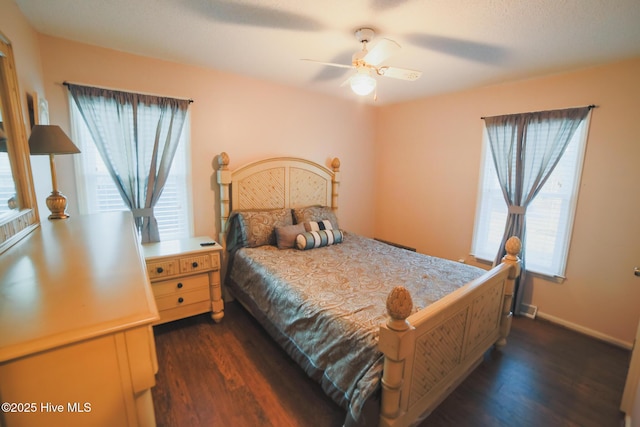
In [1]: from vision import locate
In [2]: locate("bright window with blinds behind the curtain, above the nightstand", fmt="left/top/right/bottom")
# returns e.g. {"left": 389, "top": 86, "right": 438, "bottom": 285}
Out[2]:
{"left": 69, "top": 99, "right": 192, "bottom": 240}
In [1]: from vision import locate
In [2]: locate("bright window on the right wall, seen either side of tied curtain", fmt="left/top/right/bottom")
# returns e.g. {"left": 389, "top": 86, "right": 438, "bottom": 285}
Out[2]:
{"left": 471, "top": 119, "right": 589, "bottom": 277}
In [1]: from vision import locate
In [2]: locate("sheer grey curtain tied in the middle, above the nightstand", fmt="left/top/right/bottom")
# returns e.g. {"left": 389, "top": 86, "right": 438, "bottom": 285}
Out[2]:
{"left": 66, "top": 83, "right": 191, "bottom": 243}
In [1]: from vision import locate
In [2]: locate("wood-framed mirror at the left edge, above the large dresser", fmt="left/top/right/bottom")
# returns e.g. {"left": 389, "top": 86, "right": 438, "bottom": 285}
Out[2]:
{"left": 0, "top": 33, "right": 39, "bottom": 253}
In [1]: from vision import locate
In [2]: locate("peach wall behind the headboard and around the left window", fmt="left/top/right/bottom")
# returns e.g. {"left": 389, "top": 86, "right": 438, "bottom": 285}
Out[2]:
{"left": 32, "top": 35, "right": 374, "bottom": 241}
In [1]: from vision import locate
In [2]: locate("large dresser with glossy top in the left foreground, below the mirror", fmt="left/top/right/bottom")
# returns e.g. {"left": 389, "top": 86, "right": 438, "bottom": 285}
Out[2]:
{"left": 0, "top": 212, "right": 159, "bottom": 427}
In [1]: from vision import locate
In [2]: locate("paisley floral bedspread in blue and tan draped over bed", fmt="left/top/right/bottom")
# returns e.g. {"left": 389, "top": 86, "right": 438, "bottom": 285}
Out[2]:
{"left": 227, "top": 233, "right": 485, "bottom": 426}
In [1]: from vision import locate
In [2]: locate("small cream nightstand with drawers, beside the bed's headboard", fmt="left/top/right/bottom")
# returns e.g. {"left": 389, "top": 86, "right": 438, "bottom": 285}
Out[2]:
{"left": 142, "top": 237, "right": 224, "bottom": 325}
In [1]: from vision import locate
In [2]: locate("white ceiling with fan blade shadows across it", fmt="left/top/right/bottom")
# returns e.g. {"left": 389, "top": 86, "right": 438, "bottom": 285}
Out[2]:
{"left": 15, "top": 0, "right": 640, "bottom": 104}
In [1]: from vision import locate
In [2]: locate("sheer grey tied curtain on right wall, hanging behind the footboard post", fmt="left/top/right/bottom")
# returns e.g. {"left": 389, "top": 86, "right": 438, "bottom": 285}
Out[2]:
{"left": 483, "top": 106, "right": 592, "bottom": 314}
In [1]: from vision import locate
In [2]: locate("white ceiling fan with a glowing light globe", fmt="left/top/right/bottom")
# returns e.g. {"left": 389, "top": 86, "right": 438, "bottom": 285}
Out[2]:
{"left": 303, "top": 28, "right": 422, "bottom": 97}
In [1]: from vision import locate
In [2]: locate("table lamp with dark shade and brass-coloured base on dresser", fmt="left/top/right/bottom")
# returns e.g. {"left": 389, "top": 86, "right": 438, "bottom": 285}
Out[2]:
{"left": 29, "top": 125, "right": 80, "bottom": 219}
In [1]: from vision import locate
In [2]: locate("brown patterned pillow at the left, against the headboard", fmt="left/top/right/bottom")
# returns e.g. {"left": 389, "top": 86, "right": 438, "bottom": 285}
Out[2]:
{"left": 238, "top": 208, "right": 293, "bottom": 248}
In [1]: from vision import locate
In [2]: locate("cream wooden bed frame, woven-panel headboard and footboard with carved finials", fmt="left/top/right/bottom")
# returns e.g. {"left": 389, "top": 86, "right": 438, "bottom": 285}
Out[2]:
{"left": 217, "top": 153, "right": 520, "bottom": 426}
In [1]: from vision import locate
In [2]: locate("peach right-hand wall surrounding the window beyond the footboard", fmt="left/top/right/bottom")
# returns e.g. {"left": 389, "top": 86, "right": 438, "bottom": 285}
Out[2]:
{"left": 375, "top": 58, "right": 640, "bottom": 346}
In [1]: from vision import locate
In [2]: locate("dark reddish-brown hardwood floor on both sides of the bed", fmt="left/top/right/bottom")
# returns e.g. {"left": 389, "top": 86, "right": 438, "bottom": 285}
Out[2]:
{"left": 153, "top": 303, "right": 630, "bottom": 427}
